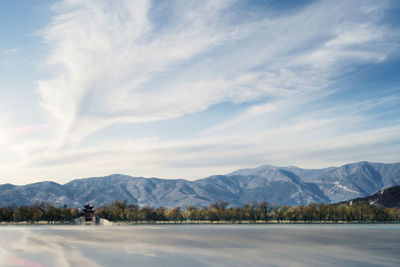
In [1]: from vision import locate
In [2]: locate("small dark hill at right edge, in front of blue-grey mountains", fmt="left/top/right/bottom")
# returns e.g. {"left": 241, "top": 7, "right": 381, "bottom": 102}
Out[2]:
{"left": 345, "top": 185, "right": 400, "bottom": 208}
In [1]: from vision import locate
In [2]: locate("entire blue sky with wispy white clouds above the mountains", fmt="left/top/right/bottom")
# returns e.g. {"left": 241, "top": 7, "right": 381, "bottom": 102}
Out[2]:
{"left": 0, "top": 0, "right": 400, "bottom": 184}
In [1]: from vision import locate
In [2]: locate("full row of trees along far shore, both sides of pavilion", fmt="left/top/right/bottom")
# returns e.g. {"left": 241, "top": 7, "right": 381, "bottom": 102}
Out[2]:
{"left": 0, "top": 201, "right": 400, "bottom": 223}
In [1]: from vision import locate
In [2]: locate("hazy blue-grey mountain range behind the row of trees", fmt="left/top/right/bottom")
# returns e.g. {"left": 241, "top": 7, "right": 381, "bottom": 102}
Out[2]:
{"left": 0, "top": 161, "right": 400, "bottom": 208}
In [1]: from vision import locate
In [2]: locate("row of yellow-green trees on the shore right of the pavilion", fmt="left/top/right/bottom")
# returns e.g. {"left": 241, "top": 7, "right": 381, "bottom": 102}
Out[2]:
{"left": 96, "top": 201, "right": 400, "bottom": 223}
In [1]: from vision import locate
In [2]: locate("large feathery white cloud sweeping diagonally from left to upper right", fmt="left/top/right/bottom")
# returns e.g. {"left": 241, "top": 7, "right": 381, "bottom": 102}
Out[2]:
{"left": 38, "top": 1, "right": 391, "bottom": 137}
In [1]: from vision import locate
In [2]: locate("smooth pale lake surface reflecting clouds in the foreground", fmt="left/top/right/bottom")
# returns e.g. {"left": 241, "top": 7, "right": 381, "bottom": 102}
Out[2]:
{"left": 0, "top": 225, "right": 400, "bottom": 267}
